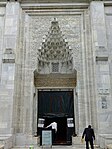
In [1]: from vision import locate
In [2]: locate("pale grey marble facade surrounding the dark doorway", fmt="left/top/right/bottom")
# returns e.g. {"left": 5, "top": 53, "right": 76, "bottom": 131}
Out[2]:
{"left": 0, "top": 0, "right": 112, "bottom": 148}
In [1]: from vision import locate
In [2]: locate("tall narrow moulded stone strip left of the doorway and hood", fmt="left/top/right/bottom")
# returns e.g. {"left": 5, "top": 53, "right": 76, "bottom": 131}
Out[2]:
{"left": 21, "top": 14, "right": 37, "bottom": 135}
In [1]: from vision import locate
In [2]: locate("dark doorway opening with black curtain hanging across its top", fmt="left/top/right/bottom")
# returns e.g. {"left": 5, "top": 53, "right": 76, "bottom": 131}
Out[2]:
{"left": 38, "top": 91, "right": 75, "bottom": 145}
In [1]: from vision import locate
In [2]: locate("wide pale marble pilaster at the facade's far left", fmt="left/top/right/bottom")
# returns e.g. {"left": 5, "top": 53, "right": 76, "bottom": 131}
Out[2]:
{"left": 0, "top": 2, "right": 19, "bottom": 135}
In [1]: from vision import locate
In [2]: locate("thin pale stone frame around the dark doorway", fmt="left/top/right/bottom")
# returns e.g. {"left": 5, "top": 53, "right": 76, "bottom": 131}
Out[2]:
{"left": 32, "top": 87, "right": 79, "bottom": 138}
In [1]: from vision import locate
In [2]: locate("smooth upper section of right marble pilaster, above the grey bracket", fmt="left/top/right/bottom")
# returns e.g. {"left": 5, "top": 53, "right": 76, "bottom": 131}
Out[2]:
{"left": 90, "top": 1, "right": 107, "bottom": 49}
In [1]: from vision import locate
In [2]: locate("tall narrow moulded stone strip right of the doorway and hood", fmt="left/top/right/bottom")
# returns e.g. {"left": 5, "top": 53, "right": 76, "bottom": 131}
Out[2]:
{"left": 77, "top": 10, "right": 91, "bottom": 134}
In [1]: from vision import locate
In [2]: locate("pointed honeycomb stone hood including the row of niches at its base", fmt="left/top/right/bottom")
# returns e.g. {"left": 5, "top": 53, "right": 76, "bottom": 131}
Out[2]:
{"left": 37, "top": 18, "right": 73, "bottom": 72}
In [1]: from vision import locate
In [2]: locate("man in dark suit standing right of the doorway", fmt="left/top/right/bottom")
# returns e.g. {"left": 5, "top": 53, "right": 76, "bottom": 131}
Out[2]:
{"left": 82, "top": 125, "right": 95, "bottom": 149}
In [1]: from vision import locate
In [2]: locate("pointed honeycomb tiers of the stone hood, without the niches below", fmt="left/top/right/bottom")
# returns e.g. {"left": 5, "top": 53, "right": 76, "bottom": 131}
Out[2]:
{"left": 38, "top": 18, "right": 72, "bottom": 62}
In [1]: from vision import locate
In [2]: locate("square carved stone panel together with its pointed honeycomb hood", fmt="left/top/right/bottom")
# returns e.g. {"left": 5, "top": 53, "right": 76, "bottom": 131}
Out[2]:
{"left": 30, "top": 16, "right": 81, "bottom": 73}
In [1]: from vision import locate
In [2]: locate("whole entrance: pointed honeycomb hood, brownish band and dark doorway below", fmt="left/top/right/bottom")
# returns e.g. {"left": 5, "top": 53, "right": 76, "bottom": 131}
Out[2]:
{"left": 34, "top": 18, "right": 77, "bottom": 144}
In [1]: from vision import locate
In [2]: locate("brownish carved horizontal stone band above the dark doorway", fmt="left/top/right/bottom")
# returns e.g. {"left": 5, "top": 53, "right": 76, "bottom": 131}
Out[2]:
{"left": 34, "top": 74, "right": 76, "bottom": 88}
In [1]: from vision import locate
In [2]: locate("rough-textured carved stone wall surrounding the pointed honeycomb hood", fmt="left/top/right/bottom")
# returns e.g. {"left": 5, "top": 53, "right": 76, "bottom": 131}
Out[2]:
{"left": 29, "top": 14, "right": 81, "bottom": 73}
